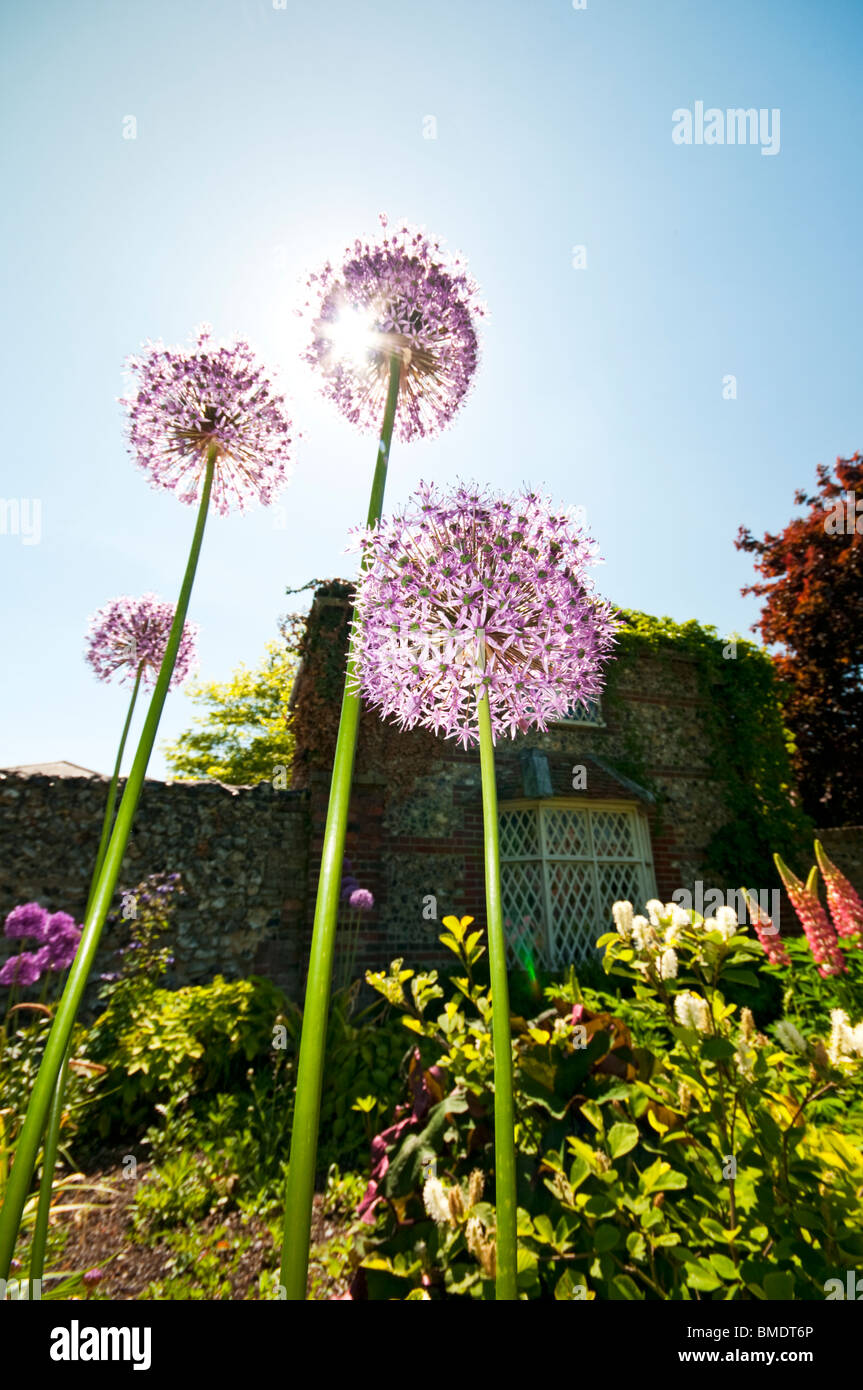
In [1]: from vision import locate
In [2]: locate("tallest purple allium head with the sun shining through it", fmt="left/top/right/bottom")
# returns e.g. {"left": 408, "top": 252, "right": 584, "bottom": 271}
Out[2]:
{"left": 300, "top": 217, "right": 486, "bottom": 441}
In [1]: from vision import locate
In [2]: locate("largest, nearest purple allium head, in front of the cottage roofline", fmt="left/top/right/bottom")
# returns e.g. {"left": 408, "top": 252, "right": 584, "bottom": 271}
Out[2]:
{"left": 353, "top": 484, "right": 620, "bottom": 746}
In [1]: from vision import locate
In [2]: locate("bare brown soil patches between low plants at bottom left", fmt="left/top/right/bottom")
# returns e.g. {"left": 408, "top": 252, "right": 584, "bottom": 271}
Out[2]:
{"left": 49, "top": 1154, "right": 347, "bottom": 1300}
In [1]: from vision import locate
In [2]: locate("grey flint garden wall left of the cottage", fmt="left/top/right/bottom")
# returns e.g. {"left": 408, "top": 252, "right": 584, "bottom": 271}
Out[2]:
{"left": 0, "top": 771, "right": 309, "bottom": 1011}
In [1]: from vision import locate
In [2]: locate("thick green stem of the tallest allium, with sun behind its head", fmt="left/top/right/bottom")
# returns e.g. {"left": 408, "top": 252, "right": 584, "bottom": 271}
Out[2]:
{"left": 279, "top": 353, "right": 400, "bottom": 1302}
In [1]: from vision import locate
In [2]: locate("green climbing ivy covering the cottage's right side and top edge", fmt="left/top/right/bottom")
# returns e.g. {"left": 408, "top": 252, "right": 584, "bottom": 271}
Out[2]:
{"left": 607, "top": 609, "right": 813, "bottom": 888}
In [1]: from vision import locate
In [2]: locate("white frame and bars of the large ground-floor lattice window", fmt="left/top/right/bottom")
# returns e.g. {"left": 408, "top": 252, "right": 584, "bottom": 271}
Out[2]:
{"left": 498, "top": 796, "right": 656, "bottom": 969}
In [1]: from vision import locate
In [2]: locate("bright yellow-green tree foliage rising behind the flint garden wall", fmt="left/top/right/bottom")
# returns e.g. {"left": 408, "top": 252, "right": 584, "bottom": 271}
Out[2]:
{"left": 164, "top": 641, "right": 297, "bottom": 785}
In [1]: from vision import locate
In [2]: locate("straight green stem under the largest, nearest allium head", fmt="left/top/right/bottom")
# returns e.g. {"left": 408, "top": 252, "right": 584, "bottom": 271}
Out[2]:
{"left": 477, "top": 645, "right": 518, "bottom": 1300}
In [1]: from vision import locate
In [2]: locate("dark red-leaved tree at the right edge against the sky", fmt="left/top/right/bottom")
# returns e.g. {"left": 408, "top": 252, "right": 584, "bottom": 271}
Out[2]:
{"left": 735, "top": 453, "right": 863, "bottom": 826}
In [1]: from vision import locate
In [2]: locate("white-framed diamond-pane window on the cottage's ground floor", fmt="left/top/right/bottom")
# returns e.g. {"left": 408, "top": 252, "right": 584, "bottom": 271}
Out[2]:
{"left": 500, "top": 799, "right": 656, "bottom": 970}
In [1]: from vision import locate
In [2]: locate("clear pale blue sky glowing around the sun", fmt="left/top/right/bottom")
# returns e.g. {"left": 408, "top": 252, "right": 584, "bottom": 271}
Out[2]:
{"left": 0, "top": 0, "right": 863, "bottom": 776}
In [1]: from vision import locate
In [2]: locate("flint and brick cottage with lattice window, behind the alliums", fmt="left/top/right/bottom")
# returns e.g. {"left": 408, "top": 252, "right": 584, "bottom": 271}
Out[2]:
{"left": 293, "top": 581, "right": 796, "bottom": 969}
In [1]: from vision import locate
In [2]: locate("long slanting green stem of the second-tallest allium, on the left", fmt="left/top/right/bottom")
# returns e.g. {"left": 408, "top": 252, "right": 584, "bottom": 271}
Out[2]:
{"left": 0, "top": 446, "right": 217, "bottom": 1279}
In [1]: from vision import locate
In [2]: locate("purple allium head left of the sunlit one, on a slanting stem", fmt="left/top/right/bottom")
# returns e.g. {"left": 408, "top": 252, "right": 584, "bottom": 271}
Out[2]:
{"left": 121, "top": 324, "right": 292, "bottom": 516}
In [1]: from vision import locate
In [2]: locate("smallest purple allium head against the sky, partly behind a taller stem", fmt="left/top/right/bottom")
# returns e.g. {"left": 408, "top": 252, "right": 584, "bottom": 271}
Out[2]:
{"left": 86, "top": 594, "right": 199, "bottom": 688}
